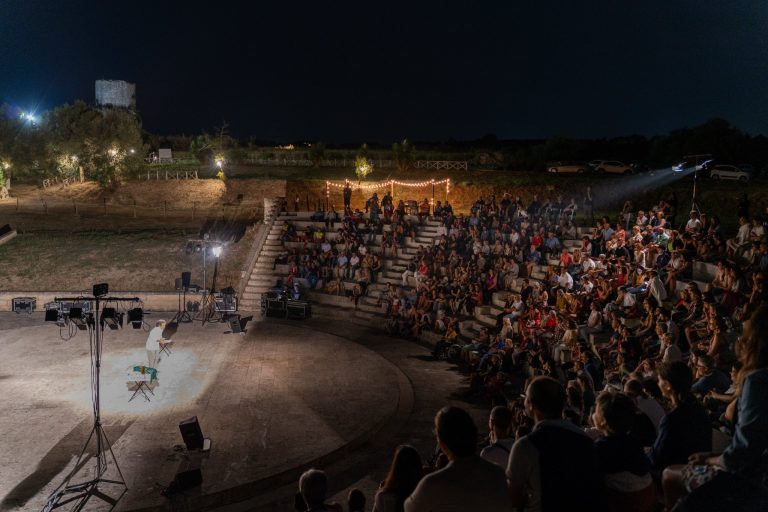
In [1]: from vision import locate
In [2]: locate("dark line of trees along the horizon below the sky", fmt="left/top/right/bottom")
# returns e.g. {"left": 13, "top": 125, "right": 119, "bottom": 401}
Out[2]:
{"left": 0, "top": 97, "right": 768, "bottom": 188}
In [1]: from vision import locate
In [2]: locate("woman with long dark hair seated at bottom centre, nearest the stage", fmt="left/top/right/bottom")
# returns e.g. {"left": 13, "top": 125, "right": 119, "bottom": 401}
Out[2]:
{"left": 373, "top": 444, "right": 424, "bottom": 512}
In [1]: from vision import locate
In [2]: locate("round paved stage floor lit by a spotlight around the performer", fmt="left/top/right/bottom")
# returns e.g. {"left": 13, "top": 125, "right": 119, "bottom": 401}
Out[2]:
{"left": 0, "top": 313, "right": 409, "bottom": 510}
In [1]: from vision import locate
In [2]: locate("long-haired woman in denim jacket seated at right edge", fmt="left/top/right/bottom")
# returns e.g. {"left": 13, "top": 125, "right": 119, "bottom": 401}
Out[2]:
{"left": 663, "top": 302, "right": 768, "bottom": 511}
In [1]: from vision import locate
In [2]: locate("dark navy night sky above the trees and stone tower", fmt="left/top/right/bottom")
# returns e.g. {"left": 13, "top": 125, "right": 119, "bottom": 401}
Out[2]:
{"left": 0, "top": 0, "right": 768, "bottom": 142}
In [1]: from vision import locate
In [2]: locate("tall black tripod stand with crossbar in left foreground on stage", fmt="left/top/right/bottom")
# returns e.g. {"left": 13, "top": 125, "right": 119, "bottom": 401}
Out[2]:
{"left": 43, "top": 297, "right": 139, "bottom": 512}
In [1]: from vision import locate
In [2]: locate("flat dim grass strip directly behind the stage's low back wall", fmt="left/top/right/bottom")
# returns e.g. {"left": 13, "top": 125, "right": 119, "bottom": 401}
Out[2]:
{"left": 0, "top": 230, "right": 256, "bottom": 291}
